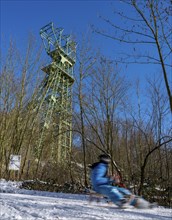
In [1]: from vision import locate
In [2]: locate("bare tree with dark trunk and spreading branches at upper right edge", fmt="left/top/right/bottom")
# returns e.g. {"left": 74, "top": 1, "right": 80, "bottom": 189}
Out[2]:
{"left": 94, "top": 0, "right": 172, "bottom": 112}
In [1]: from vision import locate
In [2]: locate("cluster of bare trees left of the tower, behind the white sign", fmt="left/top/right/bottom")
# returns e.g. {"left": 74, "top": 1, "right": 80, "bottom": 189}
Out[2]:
{"left": 0, "top": 35, "right": 44, "bottom": 177}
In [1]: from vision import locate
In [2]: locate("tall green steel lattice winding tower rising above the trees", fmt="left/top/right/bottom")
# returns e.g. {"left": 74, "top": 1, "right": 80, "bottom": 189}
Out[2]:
{"left": 38, "top": 23, "right": 76, "bottom": 162}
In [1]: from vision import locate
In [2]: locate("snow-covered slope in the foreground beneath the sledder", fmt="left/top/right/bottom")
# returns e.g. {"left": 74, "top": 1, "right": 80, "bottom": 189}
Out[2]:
{"left": 0, "top": 180, "right": 172, "bottom": 220}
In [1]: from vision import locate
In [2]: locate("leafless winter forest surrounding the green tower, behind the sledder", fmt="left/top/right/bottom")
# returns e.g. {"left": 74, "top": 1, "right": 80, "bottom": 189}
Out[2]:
{"left": 0, "top": 0, "right": 172, "bottom": 207}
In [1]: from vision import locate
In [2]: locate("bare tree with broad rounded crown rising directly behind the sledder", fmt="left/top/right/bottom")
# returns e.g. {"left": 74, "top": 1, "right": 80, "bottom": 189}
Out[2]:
{"left": 84, "top": 57, "right": 128, "bottom": 176}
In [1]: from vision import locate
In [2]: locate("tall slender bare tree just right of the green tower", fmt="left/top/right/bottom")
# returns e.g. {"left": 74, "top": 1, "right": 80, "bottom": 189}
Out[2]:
{"left": 74, "top": 34, "right": 96, "bottom": 186}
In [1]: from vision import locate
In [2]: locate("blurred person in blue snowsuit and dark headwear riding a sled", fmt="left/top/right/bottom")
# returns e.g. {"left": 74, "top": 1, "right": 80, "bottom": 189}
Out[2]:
{"left": 91, "top": 154, "right": 132, "bottom": 207}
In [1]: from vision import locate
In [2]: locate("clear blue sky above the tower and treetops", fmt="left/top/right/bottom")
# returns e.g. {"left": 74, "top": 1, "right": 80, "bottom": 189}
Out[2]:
{"left": 0, "top": 0, "right": 169, "bottom": 109}
